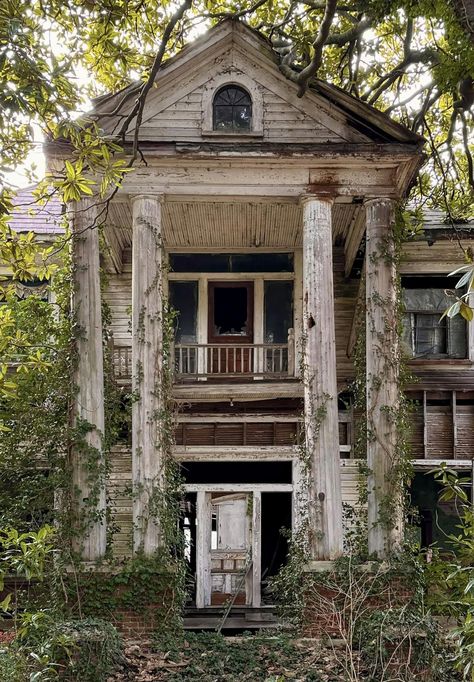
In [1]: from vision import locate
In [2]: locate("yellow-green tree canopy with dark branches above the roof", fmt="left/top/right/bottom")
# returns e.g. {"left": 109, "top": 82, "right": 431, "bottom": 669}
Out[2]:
{"left": 0, "top": 0, "right": 474, "bottom": 219}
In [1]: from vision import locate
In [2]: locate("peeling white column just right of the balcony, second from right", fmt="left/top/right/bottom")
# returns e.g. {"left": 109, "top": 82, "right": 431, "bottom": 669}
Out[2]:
{"left": 302, "top": 196, "right": 342, "bottom": 561}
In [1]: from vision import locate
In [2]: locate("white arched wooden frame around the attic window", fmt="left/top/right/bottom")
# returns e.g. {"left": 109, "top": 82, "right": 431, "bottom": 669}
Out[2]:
{"left": 201, "top": 71, "right": 263, "bottom": 139}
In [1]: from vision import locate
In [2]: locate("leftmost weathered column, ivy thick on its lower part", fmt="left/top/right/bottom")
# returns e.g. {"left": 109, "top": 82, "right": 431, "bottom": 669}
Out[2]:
{"left": 71, "top": 198, "right": 106, "bottom": 561}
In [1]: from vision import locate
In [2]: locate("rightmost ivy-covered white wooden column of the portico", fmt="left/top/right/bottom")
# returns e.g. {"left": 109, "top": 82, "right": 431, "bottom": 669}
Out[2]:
{"left": 365, "top": 199, "right": 402, "bottom": 558}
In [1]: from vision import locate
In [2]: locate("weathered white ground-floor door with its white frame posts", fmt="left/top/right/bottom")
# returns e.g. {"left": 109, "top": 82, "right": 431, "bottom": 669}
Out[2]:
{"left": 196, "top": 492, "right": 261, "bottom": 608}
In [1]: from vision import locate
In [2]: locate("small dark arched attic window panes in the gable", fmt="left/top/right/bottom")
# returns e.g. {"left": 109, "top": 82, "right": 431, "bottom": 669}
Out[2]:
{"left": 212, "top": 84, "right": 252, "bottom": 133}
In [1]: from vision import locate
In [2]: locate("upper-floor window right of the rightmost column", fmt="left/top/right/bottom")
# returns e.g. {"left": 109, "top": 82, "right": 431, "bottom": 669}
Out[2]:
{"left": 402, "top": 277, "right": 467, "bottom": 359}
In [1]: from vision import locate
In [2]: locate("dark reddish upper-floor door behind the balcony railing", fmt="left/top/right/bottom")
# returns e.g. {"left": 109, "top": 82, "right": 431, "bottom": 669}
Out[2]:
{"left": 207, "top": 282, "right": 254, "bottom": 375}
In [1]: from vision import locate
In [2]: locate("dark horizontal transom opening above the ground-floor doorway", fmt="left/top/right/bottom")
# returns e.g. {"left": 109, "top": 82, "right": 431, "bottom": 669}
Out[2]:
{"left": 181, "top": 462, "right": 291, "bottom": 484}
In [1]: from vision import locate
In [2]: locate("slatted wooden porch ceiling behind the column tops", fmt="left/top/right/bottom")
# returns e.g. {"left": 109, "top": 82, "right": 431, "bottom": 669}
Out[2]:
{"left": 106, "top": 201, "right": 361, "bottom": 250}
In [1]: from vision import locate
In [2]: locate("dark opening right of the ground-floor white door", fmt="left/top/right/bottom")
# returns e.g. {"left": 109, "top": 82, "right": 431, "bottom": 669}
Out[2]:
{"left": 262, "top": 493, "right": 291, "bottom": 603}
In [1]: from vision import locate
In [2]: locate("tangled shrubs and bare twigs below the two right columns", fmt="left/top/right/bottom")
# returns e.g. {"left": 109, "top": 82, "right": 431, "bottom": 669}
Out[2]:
{"left": 306, "top": 549, "right": 456, "bottom": 682}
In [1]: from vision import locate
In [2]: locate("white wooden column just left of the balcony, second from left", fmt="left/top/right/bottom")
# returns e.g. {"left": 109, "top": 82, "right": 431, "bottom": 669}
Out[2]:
{"left": 132, "top": 195, "right": 163, "bottom": 555}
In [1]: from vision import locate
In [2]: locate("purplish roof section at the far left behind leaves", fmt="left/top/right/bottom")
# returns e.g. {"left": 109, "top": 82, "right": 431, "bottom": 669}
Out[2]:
{"left": 9, "top": 185, "right": 64, "bottom": 234}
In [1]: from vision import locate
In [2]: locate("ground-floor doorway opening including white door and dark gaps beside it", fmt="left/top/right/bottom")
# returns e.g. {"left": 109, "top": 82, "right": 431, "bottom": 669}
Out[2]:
{"left": 182, "top": 486, "right": 292, "bottom": 608}
